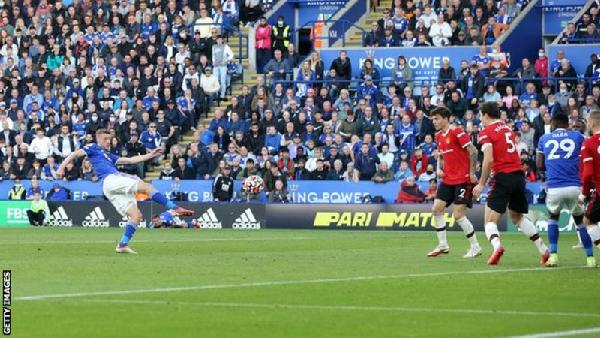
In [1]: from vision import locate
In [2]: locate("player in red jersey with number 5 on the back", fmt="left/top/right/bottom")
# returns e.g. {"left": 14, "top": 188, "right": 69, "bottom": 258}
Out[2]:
{"left": 473, "top": 102, "right": 550, "bottom": 265}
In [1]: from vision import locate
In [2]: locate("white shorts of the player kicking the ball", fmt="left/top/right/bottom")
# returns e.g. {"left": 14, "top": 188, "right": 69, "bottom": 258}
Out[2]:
{"left": 102, "top": 173, "right": 140, "bottom": 216}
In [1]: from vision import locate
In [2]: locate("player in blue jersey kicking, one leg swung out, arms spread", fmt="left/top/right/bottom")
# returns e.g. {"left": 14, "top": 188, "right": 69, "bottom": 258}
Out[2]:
{"left": 56, "top": 129, "right": 194, "bottom": 253}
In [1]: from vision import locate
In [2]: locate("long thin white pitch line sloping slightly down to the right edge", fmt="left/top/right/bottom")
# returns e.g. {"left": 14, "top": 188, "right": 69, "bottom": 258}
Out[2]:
{"left": 76, "top": 299, "right": 600, "bottom": 318}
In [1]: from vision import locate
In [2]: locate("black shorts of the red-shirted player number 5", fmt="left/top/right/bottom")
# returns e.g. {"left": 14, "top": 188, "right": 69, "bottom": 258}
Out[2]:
{"left": 487, "top": 171, "right": 529, "bottom": 214}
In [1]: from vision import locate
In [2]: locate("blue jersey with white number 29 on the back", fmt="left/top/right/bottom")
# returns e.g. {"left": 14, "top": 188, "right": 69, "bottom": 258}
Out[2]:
{"left": 537, "top": 129, "right": 584, "bottom": 188}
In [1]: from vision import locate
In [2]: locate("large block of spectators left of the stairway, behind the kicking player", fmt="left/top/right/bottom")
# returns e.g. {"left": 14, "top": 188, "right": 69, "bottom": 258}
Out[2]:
{"left": 0, "top": 0, "right": 272, "bottom": 180}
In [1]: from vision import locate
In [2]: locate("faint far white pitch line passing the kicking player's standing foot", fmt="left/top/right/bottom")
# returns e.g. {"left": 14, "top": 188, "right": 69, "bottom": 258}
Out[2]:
{"left": 0, "top": 237, "right": 319, "bottom": 245}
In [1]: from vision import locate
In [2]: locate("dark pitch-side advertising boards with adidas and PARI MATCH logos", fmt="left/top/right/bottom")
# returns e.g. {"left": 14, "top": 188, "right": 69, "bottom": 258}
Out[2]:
{"left": 0, "top": 201, "right": 577, "bottom": 232}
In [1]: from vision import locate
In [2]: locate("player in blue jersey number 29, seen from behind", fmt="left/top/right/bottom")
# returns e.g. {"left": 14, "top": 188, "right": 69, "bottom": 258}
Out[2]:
{"left": 537, "top": 114, "right": 596, "bottom": 267}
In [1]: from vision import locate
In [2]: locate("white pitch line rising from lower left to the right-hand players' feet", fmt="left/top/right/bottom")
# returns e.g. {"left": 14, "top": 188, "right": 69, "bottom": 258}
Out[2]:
{"left": 13, "top": 267, "right": 579, "bottom": 300}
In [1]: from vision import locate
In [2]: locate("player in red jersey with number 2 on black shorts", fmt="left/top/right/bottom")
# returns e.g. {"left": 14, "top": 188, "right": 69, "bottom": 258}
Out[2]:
{"left": 427, "top": 107, "right": 481, "bottom": 258}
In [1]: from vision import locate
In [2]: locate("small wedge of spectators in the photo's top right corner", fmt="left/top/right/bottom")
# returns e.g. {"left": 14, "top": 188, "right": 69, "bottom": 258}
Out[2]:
{"left": 557, "top": 0, "right": 600, "bottom": 44}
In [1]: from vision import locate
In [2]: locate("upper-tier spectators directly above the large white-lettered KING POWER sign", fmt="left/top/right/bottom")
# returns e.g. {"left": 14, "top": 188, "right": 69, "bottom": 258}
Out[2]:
{"left": 363, "top": 0, "right": 528, "bottom": 47}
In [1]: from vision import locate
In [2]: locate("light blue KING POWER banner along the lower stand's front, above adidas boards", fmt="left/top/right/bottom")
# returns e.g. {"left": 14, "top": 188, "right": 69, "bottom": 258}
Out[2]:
{"left": 0, "top": 180, "right": 542, "bottom": 204}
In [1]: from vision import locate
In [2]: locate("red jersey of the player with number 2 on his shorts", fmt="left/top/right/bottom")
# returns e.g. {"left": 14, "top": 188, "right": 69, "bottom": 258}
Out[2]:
{"left": 435, "top": 126, "right": 471, "bottom": 185}
